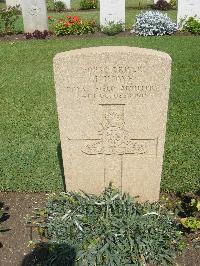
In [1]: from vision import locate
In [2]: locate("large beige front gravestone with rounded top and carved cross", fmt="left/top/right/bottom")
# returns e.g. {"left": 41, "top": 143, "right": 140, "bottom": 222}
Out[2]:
{"left": 54, "top": 46, "right": 171, "bottom": 201}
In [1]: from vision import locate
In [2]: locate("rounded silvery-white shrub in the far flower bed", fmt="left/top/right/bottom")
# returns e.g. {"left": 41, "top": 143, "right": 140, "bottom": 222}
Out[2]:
{"left": 131, "top": 11, "right": 177, "bottom": 36}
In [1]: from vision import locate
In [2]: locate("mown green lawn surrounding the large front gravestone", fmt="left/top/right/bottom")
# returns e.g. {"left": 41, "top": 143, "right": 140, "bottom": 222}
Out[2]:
{"left": 0, "top": 36, "right": 200, "bottom": 192}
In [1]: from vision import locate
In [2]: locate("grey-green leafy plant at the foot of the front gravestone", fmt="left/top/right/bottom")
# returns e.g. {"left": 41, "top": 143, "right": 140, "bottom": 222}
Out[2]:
{"left": 32, "top": 187, "right": 182, "bottom": 266}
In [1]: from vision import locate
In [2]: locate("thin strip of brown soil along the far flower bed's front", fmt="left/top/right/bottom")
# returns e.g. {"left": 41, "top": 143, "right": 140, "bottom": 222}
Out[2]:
{"left": 0, "top": 30, "right": 192, "bottom": 42}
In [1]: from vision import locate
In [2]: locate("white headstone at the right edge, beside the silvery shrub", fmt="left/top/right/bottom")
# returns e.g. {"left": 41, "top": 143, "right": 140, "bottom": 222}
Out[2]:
{"left": 177, "top": 0, "right": 200, "bottom": 28}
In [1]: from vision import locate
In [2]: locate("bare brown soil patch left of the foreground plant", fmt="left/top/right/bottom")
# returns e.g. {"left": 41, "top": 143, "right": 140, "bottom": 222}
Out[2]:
{"left": 0, "top": 192, "right": 45, "bottom": 266}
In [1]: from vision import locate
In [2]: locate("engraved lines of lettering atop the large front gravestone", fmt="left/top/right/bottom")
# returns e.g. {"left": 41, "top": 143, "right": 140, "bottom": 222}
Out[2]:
{"left": 66, "top": 65, "right": 160, "bottom": 103}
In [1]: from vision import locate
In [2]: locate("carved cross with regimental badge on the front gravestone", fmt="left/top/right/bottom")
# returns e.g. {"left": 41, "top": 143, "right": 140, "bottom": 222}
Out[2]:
{"left": 70, "top": 104, "right": 157, "bottom": 187}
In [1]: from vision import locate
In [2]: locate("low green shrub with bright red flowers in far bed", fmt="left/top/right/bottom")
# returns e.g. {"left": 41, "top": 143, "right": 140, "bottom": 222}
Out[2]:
{"left": 49, "top": 16, "right": 96, "bottom": 35}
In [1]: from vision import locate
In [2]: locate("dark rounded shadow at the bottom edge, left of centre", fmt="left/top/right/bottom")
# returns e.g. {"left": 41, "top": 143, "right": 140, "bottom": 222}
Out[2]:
{"left": 21, "top": 243, "right": 76, "bottom": 266}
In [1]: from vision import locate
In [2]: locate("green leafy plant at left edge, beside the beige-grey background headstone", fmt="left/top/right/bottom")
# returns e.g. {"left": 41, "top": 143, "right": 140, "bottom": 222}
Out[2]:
{"left": 0, "top": 7, "right": 20, "bottom": 34}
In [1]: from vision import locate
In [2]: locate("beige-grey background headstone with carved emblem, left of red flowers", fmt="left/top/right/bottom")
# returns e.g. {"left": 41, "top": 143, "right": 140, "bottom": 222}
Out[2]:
{"left": 21, "top": 0, "right": 48, "bottom": 33}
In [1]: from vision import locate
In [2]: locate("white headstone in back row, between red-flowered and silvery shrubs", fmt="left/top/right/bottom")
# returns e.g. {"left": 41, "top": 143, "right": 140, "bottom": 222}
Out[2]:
{"left": 100, "top": 0, "right": 125, "bottom": 26}
